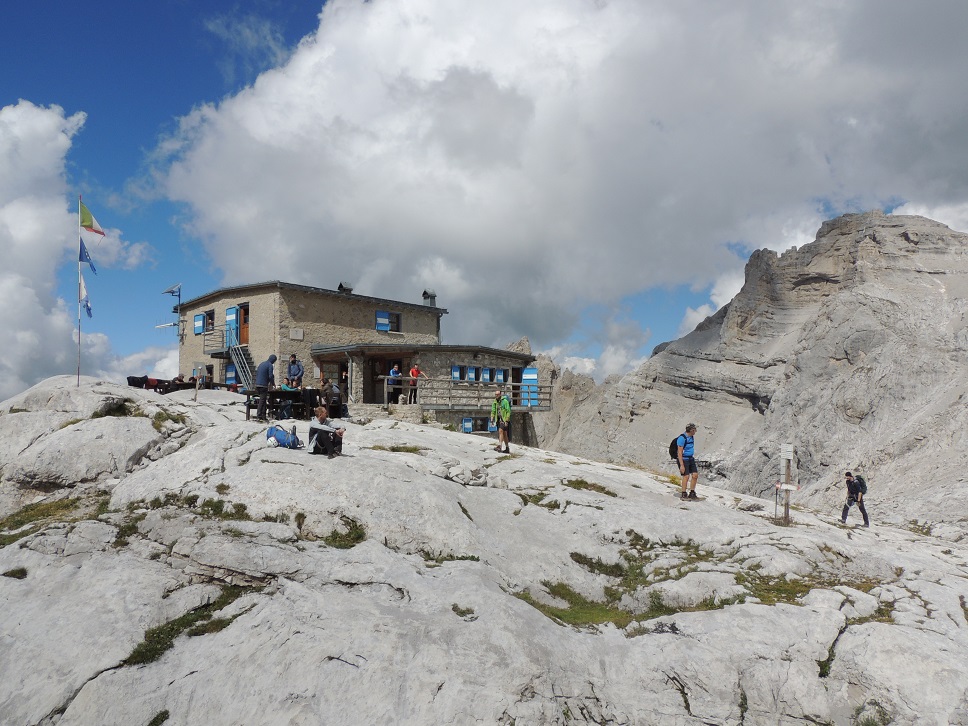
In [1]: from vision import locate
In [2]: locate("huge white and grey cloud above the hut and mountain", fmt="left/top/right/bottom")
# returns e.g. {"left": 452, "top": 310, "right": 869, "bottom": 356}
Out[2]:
{"left": 156, "top": 0, "right": 968, "bottom": 371}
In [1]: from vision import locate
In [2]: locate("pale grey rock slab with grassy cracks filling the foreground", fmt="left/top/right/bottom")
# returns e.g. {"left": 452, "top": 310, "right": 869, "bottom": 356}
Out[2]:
{"left": 0, "top": 376, "right": 968, "bottom": 726}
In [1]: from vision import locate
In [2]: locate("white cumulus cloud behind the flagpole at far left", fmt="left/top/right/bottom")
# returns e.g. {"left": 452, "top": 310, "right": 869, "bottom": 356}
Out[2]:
{"left": 0, "top": 101, "right": 172, "bottom": 400}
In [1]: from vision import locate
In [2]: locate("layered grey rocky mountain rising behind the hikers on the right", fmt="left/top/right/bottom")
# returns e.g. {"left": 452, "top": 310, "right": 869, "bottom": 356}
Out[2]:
{"left": 536, "top": 212, "right": 968, "bottom": 537}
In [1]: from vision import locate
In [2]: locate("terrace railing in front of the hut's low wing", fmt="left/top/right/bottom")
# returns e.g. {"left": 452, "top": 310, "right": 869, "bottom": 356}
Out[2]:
{"left": 379, "top": 376, "right": 552, "bottom": 411}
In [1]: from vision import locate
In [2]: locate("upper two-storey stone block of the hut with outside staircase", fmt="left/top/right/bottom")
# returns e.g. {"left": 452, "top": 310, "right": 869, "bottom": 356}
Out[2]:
{"left": 177, "top": 280, "right": 447, "bottom": 386}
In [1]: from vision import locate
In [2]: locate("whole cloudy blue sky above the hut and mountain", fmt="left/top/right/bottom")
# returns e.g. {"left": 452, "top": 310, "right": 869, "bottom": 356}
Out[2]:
{"left": 0, "top": 0, "right": 968, "bottom": 397}
